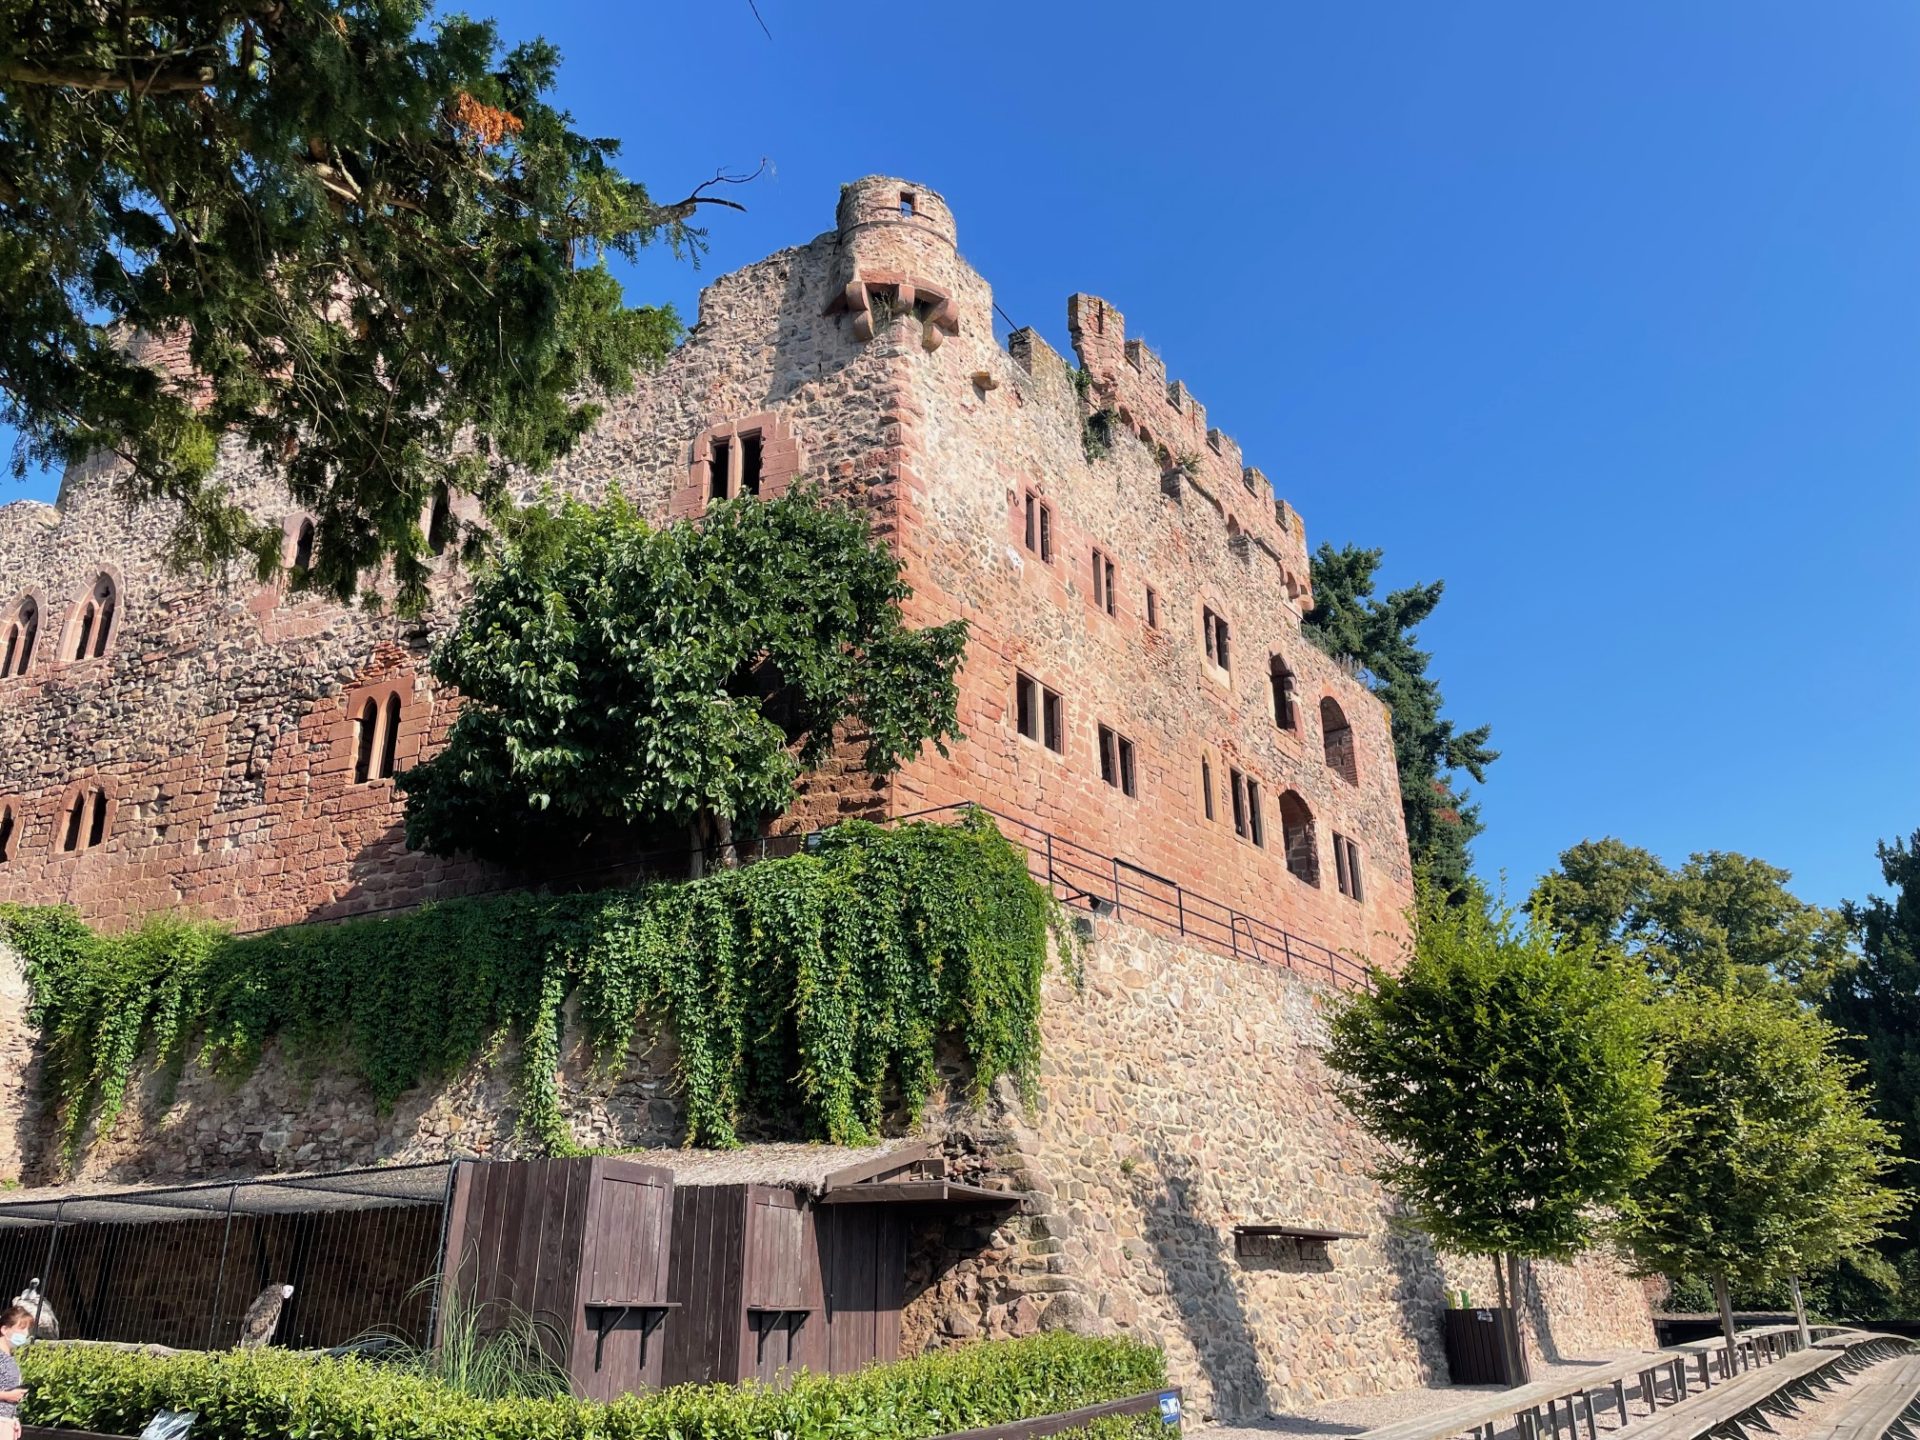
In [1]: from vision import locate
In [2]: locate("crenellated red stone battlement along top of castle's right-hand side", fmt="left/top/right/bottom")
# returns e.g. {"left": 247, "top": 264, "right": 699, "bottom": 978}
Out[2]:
{"left": 1068, "top": 294, "right": 1313, "bottom": 611}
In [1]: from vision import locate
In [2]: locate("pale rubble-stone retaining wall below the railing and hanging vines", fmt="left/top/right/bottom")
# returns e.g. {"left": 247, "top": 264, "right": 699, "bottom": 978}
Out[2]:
{"left": 0, "top": 920, "right": 1653, "bottom": 1419}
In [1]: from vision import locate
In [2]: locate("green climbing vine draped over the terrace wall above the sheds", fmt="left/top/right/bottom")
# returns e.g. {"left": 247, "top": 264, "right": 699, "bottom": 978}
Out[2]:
{"left": 0, "top": 812, "right": 1073, "bottom": 1152}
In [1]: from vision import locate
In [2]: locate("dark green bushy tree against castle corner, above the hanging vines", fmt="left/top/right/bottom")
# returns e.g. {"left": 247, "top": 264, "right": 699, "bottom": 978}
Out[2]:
{"left": 399, "top": 490, "right": 966, "bottom": 858}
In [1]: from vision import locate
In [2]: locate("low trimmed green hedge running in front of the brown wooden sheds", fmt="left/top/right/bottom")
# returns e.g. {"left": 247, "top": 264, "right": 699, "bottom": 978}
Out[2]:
{"left": 21, "top": 1332, "right": 1165, "bottom": 1440}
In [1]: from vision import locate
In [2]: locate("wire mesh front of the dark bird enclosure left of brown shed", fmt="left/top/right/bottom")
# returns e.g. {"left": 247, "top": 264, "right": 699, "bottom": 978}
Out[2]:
{"left": 0, "top": 1162, "right": 453, "bottom": 1350}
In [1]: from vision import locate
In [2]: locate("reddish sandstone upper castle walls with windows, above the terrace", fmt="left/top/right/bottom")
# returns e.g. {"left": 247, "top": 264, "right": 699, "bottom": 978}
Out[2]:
{"left": 0, "top": 180, "right": 1407, "bottom": 975}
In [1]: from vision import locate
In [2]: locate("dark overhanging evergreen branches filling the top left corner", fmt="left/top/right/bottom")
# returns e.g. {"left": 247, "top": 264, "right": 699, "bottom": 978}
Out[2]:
{"left": 0, "top": 0, "right": 732, "bottom": 609}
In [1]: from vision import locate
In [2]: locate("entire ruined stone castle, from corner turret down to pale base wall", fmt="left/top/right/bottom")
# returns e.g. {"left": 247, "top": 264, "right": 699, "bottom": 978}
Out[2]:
{"left": 0, "top": 177, "right": 1651, "bottom": 1415}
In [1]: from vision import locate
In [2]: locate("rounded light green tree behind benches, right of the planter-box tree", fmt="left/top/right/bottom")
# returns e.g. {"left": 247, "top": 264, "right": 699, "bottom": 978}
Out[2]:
{"left": 1620, "top": 985, "right": 1907, "bottom": 1344}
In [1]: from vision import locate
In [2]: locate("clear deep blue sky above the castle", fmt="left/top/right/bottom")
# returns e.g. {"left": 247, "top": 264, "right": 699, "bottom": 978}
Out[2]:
{"left": 7, "top": 0, "right": 1920, "bottom": 902}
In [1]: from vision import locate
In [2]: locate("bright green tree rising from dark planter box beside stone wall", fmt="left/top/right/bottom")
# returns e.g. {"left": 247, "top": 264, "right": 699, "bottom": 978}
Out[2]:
{"left": 1327, "top": 883, "right": 1659, "bottom": 1374}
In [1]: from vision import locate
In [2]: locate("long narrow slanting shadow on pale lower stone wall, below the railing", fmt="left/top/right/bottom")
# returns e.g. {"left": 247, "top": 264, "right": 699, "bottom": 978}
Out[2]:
{"left": 1140, "top": 1146, "right": 1267, "bottom": 1419}
